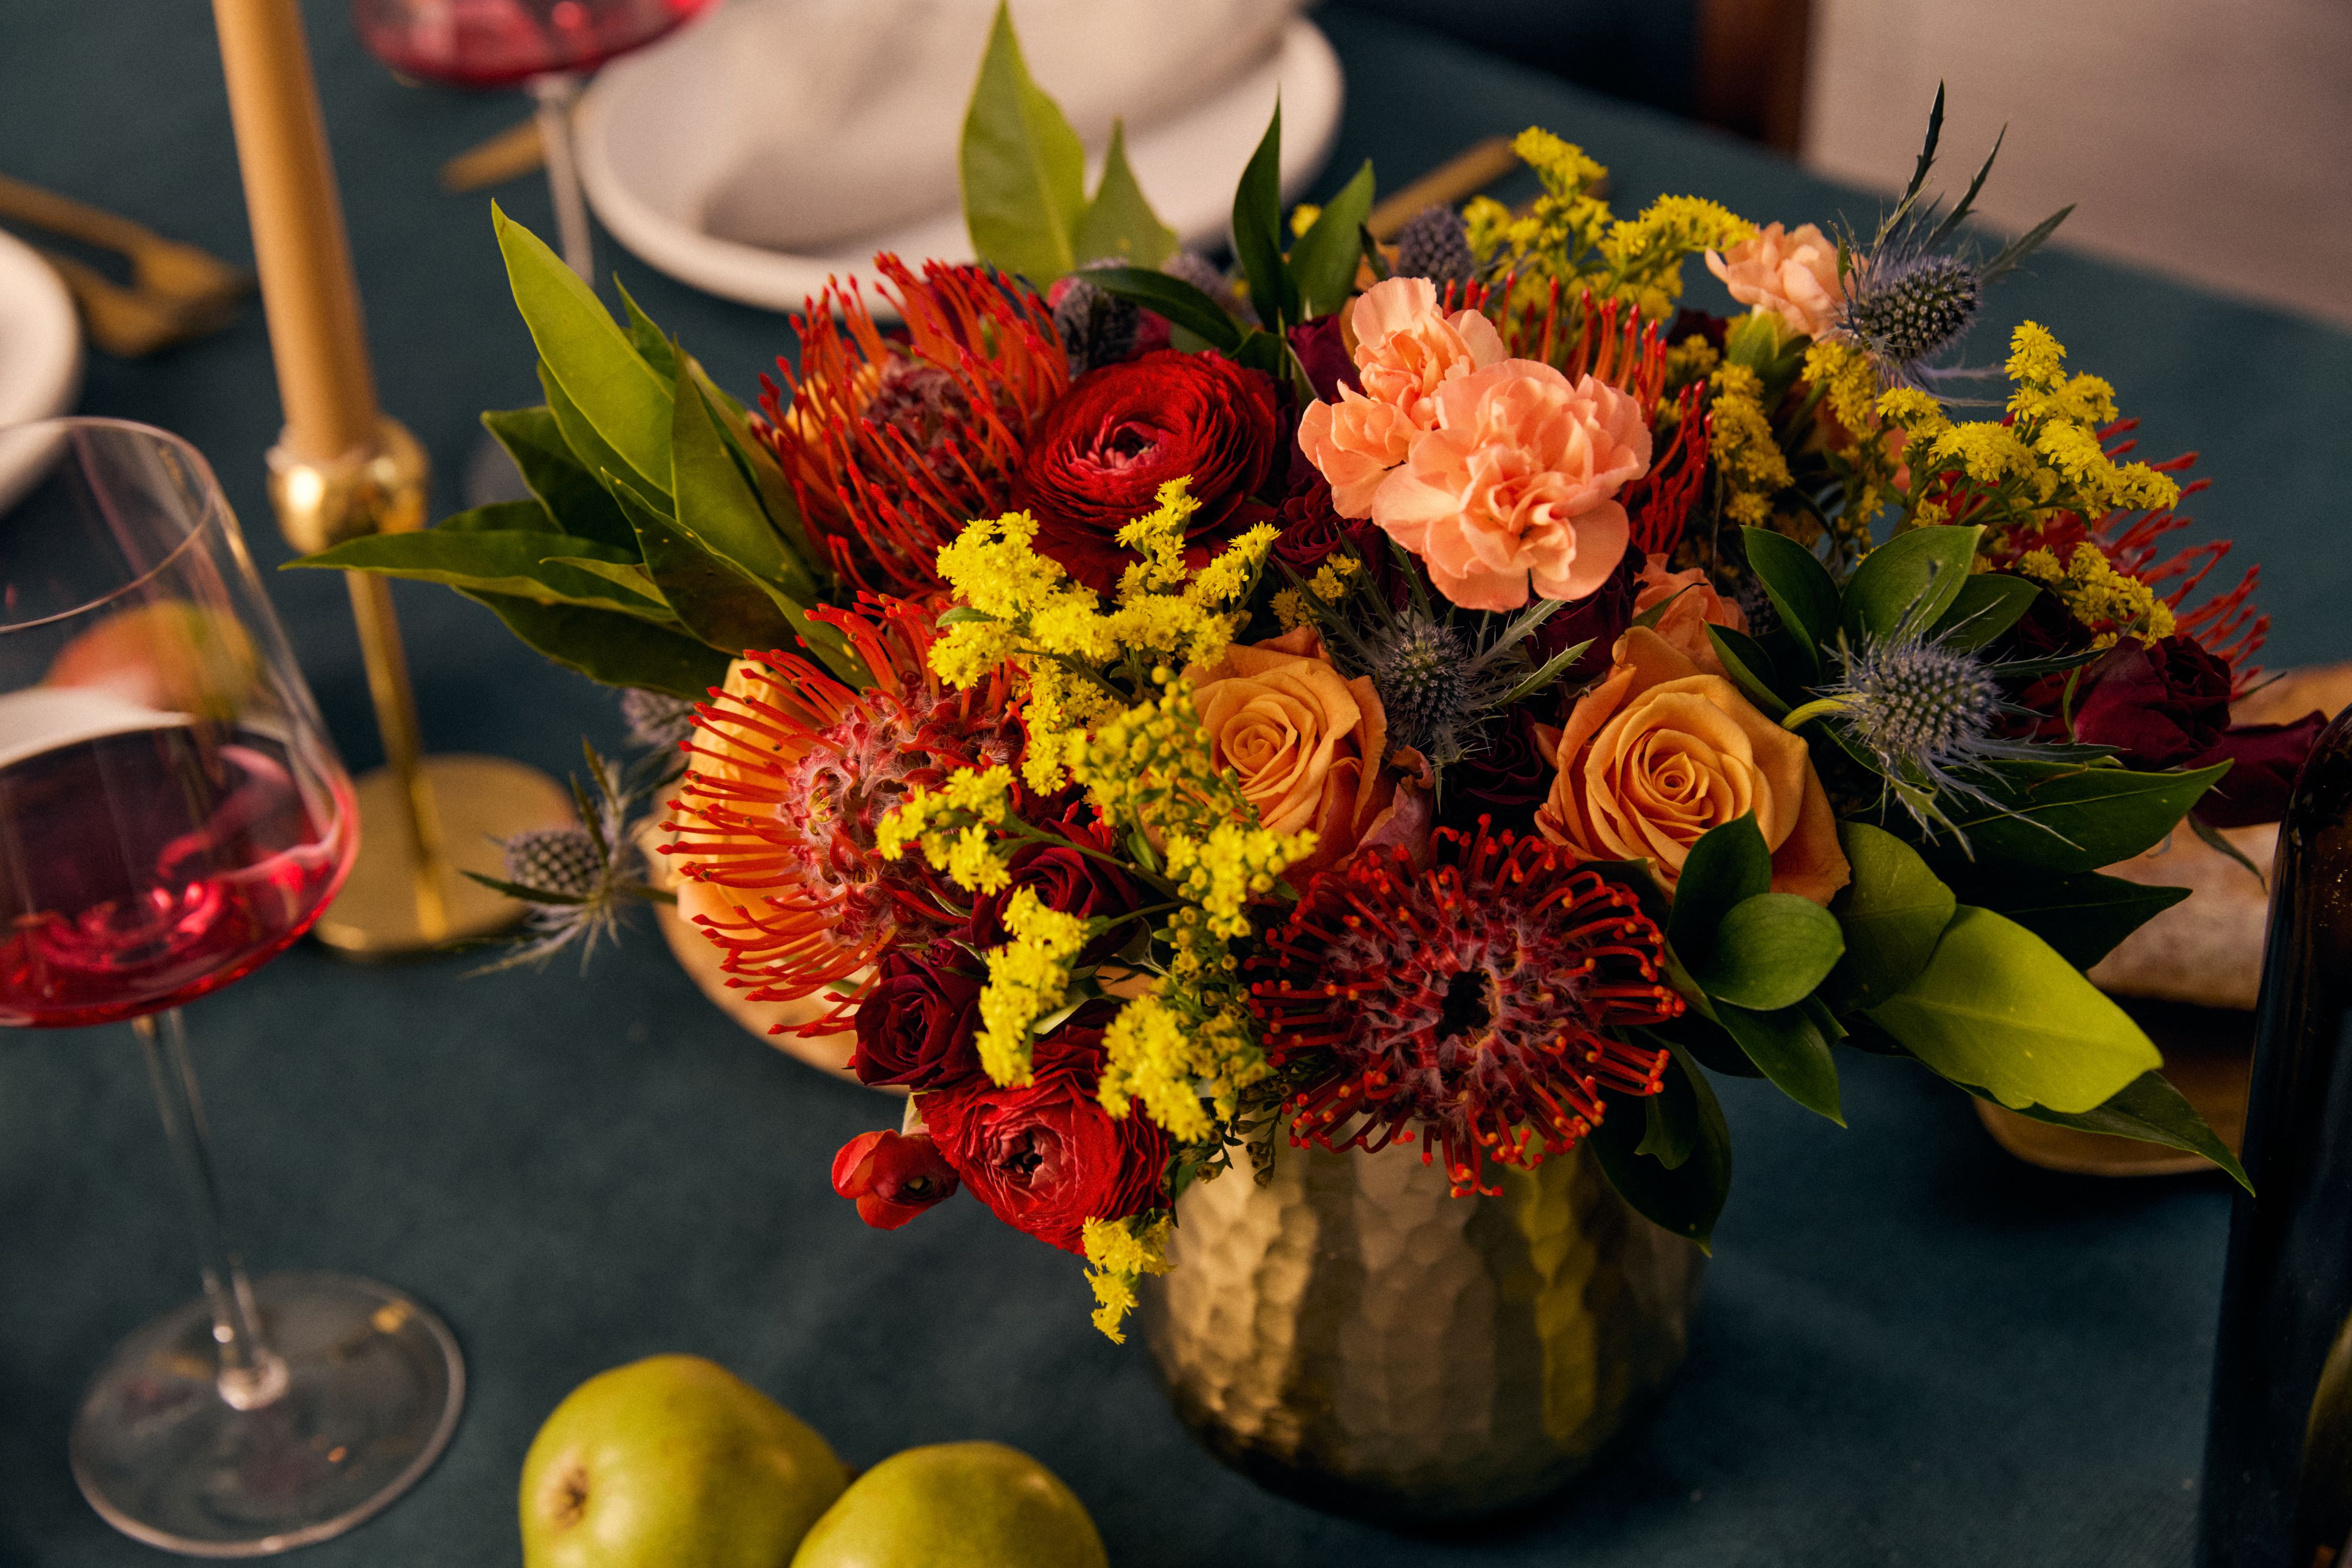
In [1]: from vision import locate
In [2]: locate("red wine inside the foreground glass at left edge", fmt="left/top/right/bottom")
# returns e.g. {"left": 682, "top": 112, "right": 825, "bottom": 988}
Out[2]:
{"left": 0, "top": 719, "right": 353, "bottom": 1027}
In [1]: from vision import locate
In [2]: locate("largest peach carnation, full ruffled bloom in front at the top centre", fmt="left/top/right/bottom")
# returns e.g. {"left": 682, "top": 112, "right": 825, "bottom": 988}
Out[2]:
{"left": 1371, "top": 360, "right": 1651, "bottom": 609}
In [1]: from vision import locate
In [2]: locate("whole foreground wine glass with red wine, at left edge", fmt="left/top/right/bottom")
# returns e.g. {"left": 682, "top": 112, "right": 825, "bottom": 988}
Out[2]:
{"left": 0, "top": 419, "right": 466, "bottom": 1556}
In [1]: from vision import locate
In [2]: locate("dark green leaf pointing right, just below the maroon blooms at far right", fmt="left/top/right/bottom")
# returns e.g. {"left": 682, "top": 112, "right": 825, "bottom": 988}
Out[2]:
{"left": 1947, "top": 762, "right": 2230, "bottom": 872}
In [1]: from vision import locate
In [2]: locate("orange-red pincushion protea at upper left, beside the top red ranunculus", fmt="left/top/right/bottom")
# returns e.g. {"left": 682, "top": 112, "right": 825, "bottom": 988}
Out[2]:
{"left": 755, "top": 254, "right": 1070, "bottom": 597}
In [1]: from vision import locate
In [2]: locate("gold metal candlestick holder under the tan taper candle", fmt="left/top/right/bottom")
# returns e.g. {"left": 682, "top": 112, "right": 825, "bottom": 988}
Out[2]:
{"left": 270, "top": 419, "right": 572, "bottom": 959}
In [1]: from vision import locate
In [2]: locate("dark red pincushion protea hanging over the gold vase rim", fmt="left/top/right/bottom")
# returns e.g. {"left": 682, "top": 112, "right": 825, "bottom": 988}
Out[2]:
{"left": 1249, "top": 818, "right": 1682, "bottom": 1194}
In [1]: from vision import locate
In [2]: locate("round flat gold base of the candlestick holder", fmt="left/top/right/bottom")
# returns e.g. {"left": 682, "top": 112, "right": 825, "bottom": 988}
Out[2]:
{"left": 310, "top": 753, "right": 572, "bottom": 959}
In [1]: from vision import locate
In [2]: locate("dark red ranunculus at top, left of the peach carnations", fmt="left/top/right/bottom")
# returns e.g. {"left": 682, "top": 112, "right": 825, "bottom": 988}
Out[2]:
{"left": 1011, "top": 348, "right": 1282, "bottom": 593}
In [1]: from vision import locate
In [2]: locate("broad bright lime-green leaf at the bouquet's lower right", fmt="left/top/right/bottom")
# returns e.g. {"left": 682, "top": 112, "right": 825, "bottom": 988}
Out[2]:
{"left": 1867, "top": 905, "right": 2164, "bottom": 1112}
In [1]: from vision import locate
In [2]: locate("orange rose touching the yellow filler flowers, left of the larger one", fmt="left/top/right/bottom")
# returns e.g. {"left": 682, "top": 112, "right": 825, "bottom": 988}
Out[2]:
{"left": 1185, "top": 626, "right": 1428, "bottom": 884}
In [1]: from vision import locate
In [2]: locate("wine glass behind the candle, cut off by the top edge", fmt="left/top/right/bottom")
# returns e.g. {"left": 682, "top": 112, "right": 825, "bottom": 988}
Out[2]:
{"left": 350, "top": 0, "right": 710, "bottom": 285}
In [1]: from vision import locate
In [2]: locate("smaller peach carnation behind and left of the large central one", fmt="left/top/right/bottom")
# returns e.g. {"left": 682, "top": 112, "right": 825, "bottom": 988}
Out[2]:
{"left": 1298, "top": 278, "right": 1503, "bottom": 517}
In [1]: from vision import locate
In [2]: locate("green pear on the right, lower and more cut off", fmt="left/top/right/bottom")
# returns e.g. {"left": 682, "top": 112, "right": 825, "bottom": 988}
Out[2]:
{"left": 793, "top": 1443, "right": 1110, "bottom": 1568}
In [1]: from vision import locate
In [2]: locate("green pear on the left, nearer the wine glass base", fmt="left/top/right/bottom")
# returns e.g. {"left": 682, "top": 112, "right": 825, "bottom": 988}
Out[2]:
{"left": 522, "top": 1356, "right": 849, "bottom": 1568}
